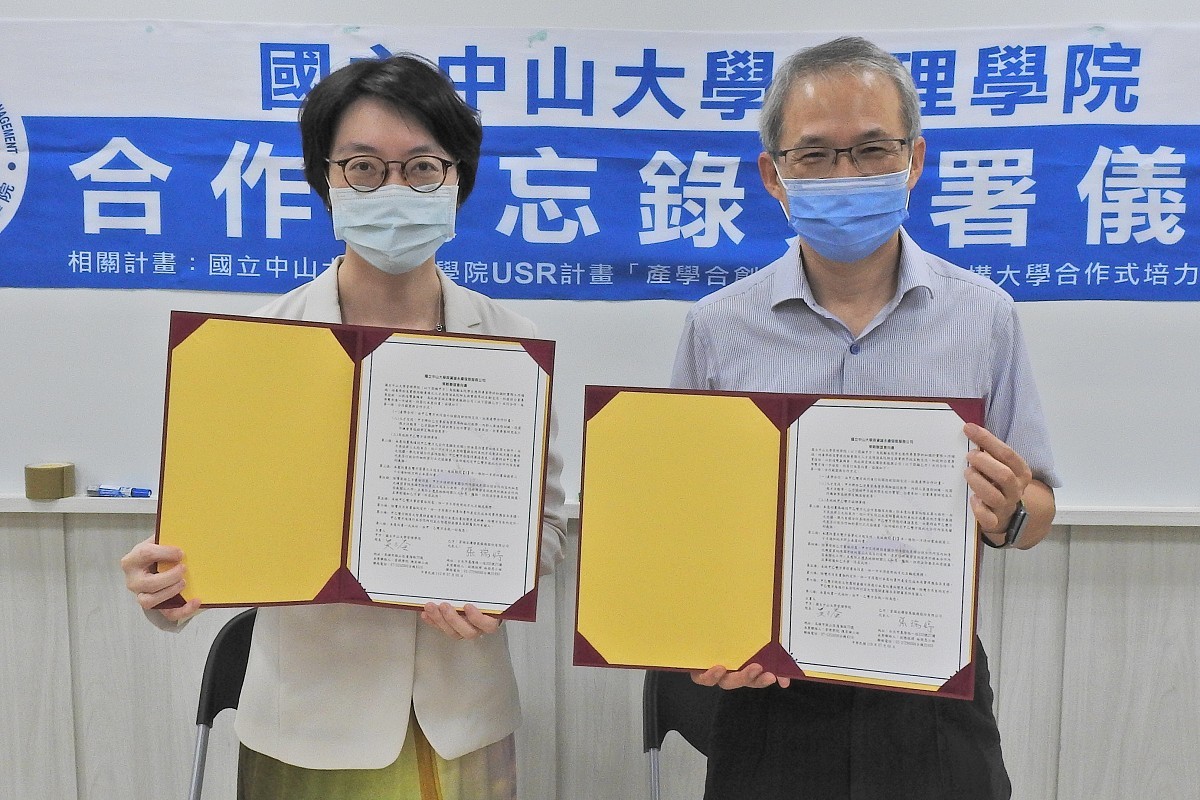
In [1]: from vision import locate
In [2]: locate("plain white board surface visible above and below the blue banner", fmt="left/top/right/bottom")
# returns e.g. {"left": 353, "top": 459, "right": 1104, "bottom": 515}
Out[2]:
{"left": 7, "top": 0, "right": 1200, "bottom": 507}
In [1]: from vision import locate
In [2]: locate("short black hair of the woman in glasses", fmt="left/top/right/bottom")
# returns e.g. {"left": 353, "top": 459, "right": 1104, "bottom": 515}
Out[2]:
{"left": 300, "top": 53, "right": 484, "bottom": 209}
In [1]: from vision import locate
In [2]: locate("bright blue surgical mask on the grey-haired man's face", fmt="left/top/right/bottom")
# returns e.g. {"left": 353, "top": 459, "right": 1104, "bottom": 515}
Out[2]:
{"left": 776, "top": 162, "right": 912, "bottom": 263}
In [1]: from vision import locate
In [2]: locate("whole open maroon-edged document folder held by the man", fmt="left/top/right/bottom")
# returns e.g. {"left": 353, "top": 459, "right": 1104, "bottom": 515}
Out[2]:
{"left": 574, "top": 386, "right": 983, "bottom": 698}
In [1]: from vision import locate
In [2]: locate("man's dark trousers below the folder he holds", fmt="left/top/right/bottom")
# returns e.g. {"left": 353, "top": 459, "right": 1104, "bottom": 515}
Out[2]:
{"left": 704, "top": 638, "right": 1012, "bottom": 800}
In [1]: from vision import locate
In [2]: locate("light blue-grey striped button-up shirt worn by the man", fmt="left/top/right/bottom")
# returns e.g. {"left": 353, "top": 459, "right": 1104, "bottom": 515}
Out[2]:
{"left": 672, "top": 229, "right": 1061, "bottom": 486}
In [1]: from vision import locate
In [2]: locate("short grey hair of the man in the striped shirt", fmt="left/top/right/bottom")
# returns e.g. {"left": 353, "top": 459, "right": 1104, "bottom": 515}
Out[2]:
{"left": 758, "top": 36, "right": 920, "bottom": 152}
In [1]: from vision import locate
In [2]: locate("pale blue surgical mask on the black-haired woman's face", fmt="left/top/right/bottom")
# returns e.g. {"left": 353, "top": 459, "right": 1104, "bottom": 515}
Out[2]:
{"left": 329, "top": 184, "right": 458, "bottom": 275}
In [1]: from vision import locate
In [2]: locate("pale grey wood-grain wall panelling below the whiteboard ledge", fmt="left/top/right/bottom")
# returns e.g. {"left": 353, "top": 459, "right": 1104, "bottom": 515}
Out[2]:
{"left": 7, "top": 513, "right": 1200, "bottom": 800}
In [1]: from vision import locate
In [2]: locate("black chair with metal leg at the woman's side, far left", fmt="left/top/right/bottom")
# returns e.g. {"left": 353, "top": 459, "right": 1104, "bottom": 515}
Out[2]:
{"left": 187, "top": 608, "right": 257, "bottom": 800}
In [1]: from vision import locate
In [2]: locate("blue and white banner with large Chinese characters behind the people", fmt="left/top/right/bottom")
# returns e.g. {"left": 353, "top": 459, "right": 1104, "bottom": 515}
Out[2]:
{"left": 0, "top": 20, "right": 1200, "bottom": 300}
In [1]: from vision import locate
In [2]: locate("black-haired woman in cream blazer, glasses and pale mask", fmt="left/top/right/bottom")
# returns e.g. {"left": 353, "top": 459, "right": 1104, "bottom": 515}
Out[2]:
{"left": 122, "top": 54, "right": 565, "bottom": 800}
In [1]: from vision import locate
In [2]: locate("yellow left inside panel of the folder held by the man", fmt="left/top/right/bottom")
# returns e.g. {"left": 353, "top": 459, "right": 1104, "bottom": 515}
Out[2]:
{"left": 577, "top": 391, "right": 781, "bottom": 668}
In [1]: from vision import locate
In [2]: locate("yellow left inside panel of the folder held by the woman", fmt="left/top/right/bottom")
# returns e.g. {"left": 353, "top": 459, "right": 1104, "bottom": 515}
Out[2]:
{"left": 158, "top": 319, "right": 354, "bottom": 604}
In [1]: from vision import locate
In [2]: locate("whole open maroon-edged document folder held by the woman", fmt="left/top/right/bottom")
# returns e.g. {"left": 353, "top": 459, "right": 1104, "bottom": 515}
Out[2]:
{"left": 155, "top": 312, "right": 554, "bottom": 620}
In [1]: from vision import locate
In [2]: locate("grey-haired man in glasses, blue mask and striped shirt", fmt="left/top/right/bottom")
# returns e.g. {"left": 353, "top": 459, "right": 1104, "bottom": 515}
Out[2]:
{"left": 673, "top": 37, "right": 1058, "bottom": 800}
